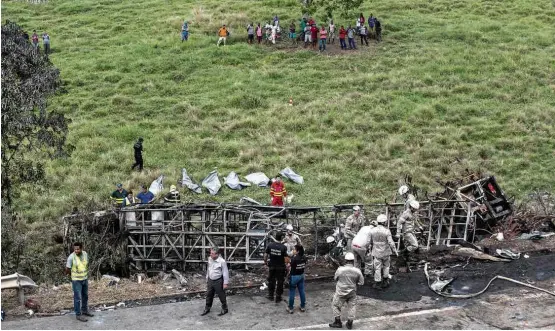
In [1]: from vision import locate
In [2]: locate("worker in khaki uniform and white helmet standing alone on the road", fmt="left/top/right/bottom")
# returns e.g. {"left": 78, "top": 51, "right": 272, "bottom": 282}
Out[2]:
{"left": 329, "top": 252, "right": 364, "bottom": 329}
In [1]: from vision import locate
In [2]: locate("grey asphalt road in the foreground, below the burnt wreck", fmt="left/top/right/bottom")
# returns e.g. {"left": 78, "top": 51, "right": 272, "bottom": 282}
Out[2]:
{"left": 1, "top": 255, "right": 555, "bottom": 330}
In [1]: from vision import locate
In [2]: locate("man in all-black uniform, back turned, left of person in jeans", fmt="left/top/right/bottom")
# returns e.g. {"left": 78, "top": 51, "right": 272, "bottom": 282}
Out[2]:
{"left": 264, "top": 232, "right": 287, "bottom": 303}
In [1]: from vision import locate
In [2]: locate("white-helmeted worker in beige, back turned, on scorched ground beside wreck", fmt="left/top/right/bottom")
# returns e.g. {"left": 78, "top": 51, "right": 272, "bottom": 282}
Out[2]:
{"left": 369, "top": 214, "right": 399, "bottom": 288}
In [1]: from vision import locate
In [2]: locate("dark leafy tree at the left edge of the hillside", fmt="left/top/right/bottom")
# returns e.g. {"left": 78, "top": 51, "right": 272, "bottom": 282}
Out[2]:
{"left": 1, "top": 22, "right": 73, "bottom": 208}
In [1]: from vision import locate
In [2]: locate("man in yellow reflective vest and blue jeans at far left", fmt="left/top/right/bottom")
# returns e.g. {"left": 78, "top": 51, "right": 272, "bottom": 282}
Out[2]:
{"left": 65, "top": 242, "right": 94, "bottom": 322}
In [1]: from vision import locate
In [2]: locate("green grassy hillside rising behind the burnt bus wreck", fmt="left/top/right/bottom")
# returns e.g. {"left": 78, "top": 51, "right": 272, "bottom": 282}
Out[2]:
{"left": 2, "top": 0, "right": 555, "bottom": 220}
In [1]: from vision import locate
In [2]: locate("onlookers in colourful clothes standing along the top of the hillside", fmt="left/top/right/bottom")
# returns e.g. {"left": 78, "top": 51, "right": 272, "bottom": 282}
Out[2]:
{"left": 181, "top": 13, "right": 382, "bottom": 52}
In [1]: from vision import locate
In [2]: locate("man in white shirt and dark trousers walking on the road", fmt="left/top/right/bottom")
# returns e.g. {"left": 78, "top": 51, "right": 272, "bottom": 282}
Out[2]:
{"left": 200, "top": 247, "right": 229, "bottom": 316}
